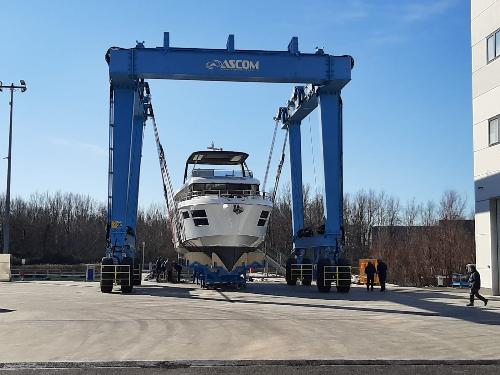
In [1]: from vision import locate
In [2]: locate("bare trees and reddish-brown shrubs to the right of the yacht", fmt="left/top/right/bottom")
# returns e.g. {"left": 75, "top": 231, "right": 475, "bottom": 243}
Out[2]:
{"left": 265, "top": 186, "right": 475, "bottom": 286}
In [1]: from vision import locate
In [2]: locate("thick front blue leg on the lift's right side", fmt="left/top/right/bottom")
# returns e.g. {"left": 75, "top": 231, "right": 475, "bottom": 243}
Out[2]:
{"left": 319, "top": 91, "right": 343, "bottom": 239}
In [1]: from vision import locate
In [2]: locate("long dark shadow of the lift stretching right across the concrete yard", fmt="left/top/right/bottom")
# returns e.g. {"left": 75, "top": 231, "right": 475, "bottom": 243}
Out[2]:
{"left": 134, "top": 283, "right": 500, "bottom": 325}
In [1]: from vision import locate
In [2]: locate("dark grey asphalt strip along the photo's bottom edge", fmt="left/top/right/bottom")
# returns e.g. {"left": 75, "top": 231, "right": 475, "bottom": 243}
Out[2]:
{"left": 0, "top": 361, "right": 500, "bottom": 375}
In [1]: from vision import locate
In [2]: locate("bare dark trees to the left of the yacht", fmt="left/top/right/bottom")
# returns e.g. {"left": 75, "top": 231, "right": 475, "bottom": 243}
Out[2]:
{"left": 0, "top": 192, "right": 176, "bottom": 264}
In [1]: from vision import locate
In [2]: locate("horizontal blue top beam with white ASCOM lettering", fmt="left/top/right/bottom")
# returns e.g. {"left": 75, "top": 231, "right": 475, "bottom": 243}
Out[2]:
{"left": 106, "top": 33, "right": 352, "bottom": 85}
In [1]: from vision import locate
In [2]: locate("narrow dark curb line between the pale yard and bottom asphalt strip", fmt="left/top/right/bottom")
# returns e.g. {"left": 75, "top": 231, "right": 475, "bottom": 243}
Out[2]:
{"left": 0, "top": 359, "right": 500, "bottom": 370}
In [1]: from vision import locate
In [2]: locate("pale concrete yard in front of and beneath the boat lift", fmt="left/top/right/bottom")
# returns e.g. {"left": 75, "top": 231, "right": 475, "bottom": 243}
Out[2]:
{"left": 0, "top": 281, "right": 500, "bottom": 362}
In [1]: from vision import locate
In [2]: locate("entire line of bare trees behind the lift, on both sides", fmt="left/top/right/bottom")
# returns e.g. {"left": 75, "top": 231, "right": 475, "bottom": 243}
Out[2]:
{"left": 0, "top": 186, "right": 475, "bottom": 285}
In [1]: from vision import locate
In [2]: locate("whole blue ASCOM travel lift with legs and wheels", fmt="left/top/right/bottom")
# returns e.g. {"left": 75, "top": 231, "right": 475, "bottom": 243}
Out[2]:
{"left": 101, "top": 33, "right": 353, "bottom": 293}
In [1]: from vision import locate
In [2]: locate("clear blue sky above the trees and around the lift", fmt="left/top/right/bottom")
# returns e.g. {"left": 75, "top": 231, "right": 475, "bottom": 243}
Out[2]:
{"left": 0, "top": 0, "right": 474, "bottom": 210}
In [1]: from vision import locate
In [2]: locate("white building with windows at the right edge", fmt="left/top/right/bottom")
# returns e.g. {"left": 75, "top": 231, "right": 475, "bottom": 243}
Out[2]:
{"left": 471, "top": 0, "right": 500, "bottom": 295}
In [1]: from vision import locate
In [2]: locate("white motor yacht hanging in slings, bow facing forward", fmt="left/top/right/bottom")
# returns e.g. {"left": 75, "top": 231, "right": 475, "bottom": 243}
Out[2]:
{"left": 174, "top": 150, "right": 272, "bottom": 271}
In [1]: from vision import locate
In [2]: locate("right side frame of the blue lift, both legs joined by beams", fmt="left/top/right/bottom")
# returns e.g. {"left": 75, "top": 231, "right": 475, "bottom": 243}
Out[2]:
{"left": 274, "top": 79, "right": 343, "bottom": 254}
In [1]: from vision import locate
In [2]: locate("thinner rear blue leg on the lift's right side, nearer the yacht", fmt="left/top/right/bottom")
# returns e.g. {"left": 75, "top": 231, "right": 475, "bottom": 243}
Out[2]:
{"left": 288, "top": 122, "right": 304, "bottom": 242}
